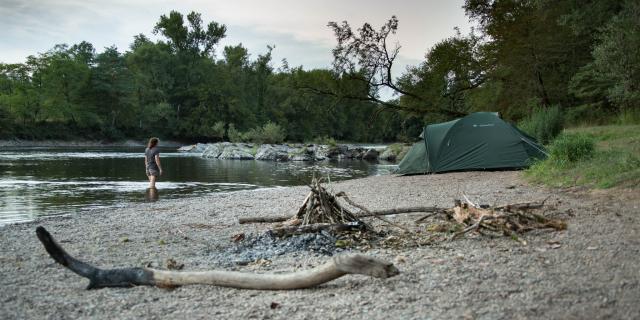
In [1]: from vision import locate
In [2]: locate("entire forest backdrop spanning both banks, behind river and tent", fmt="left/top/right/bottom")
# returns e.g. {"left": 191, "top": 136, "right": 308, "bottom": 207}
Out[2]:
{"left": 0, "top": 0, "right": 640, "bottom": 142}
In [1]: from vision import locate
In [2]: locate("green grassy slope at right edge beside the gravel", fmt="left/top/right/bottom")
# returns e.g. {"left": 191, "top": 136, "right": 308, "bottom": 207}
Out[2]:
{"left": 525, "top": 125, "right": 640, "bottom": 189}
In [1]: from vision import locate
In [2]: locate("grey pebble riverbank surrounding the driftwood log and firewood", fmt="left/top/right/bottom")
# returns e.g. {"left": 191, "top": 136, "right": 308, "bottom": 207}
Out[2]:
{"left": 0, "top": 171, "right": 640, "bottom": 319}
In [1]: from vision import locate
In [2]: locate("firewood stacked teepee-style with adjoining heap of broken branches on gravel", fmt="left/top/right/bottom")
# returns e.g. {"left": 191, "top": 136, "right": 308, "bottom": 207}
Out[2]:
{"left": 239, "top": 178, "right": 567, "bottom": 243}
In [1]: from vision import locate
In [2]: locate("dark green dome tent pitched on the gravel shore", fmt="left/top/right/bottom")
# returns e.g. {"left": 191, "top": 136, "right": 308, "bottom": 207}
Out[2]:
{"left": 396, "top": 112, "right": 546, "bottom": 174}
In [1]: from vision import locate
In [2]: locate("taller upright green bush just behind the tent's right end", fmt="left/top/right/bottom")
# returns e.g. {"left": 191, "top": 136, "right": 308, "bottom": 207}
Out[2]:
{"left": 519, "top": 106, "right": 563, "bottom": 144}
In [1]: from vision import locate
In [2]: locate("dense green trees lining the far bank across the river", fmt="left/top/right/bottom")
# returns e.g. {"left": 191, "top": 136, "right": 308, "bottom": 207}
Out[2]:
{"left": 0, "top": 11, "right": 410, "bottom": 142}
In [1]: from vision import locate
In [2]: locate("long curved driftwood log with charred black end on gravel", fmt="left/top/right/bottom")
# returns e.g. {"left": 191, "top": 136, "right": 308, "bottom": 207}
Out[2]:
{"left": 36, "top": 227, "right": 399, "bottom": 290}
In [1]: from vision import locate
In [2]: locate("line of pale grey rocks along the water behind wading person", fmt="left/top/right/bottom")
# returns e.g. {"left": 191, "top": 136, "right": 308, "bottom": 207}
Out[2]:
{"left": 178, "top": 142, "right": 399, "bottom": 161}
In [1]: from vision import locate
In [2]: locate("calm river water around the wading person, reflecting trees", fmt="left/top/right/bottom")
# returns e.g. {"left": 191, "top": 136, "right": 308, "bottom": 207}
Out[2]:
{"left": 0, "top": 147, "right": 394, "bottom": 225}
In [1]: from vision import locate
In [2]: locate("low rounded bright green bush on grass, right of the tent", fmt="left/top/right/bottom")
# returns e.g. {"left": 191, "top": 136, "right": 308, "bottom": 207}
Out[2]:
{"left": 549, "top": 133, "right": 595, "bottom": 166}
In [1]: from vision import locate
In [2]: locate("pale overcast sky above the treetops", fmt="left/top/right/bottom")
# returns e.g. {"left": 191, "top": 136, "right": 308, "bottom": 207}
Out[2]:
{"left": 0, "top": 0, "right": 470, "bottom": 69}
